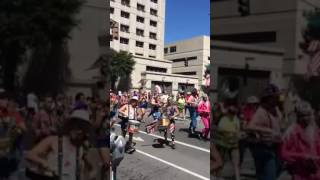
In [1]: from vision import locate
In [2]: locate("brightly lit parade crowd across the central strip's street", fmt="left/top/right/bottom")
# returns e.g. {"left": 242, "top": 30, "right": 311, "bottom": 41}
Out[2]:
{"left": 110, "top": 89, "right": 211, "bottom": 153}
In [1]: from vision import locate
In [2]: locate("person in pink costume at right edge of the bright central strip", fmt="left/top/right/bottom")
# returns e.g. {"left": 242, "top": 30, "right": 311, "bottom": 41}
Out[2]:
{"left": 198, "top": 94, "right": 211, "bottom": 140}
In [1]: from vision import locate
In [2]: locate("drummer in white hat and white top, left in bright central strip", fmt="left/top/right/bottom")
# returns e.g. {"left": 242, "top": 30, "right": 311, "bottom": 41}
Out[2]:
{"left": 119, "top": 96, "right": 141, "bottom": 153}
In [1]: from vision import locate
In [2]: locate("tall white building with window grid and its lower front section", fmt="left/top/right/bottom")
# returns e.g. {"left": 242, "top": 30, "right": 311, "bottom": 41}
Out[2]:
{"left": 110, "top": 0, "right": 198, "bottom": 94}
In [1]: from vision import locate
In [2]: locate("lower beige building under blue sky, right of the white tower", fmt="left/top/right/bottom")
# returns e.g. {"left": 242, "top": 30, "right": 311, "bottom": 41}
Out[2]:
{"left": 164, "top": 36, "right": 210, "bottom": 88}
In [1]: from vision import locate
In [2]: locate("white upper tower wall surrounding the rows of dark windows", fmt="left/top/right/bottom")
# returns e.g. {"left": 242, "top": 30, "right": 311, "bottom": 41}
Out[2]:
{"left": 110, "top": 0, "right": 165, "bottom": 59}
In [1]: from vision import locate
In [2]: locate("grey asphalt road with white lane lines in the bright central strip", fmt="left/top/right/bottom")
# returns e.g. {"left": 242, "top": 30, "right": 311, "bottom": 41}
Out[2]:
{"left": 111, "top": 112, "right": 210, "bottom": 180}
